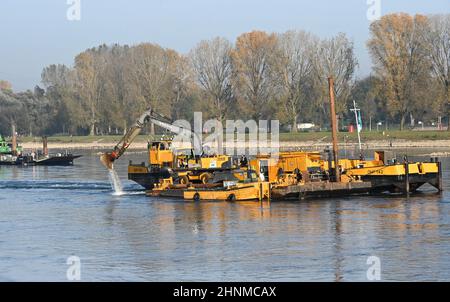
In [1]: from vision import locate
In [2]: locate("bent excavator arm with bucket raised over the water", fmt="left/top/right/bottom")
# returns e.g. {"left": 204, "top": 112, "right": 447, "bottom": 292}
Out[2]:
{"left": 100, "top": 108, "right": 200, "bottom": 169}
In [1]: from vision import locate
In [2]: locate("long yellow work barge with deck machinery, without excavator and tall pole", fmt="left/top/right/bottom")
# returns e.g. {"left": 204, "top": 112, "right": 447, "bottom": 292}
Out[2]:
{"left": 140, "top": 151, "right": 442, "bottom": 201}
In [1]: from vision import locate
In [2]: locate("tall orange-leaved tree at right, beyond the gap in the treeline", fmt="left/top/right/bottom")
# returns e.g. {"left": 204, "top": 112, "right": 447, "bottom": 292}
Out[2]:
{"left": 368, "top": 13, "right": 428, "bottom": 130}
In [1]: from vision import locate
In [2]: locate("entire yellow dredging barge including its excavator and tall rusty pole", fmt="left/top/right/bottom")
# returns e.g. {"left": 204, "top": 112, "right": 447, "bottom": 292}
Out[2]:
{"left": 100, "top": 77, "right": 443, "bottom": 201}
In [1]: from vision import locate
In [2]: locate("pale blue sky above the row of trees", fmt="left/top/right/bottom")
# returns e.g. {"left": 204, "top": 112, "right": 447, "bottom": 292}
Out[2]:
{"left": 0, "top": 0, "right": 450, "bottom": 91}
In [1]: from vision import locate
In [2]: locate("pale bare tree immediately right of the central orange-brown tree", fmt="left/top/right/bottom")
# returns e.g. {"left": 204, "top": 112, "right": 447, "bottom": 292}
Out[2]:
{"left": 274, "top": 31, "right": 315, "bottom": 132}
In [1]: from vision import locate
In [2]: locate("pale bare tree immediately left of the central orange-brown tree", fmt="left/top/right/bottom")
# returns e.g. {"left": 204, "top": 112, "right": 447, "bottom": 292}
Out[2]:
{"left": 189, "top": 37, "right": 233, "bottom": 121}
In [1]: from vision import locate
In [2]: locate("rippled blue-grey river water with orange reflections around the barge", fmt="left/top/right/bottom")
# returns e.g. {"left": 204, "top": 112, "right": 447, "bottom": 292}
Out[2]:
{"left": 0, "top": 151, "right": 450, "bottom": 281}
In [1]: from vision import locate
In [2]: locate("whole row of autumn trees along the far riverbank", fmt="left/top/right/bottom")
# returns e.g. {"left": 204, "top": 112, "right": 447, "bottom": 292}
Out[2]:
{"left": 0, "top": 14, "right": 450, "bottom": 135}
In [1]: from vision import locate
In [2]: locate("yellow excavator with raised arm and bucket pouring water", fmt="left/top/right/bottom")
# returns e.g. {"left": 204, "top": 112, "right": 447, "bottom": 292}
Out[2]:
{"left": 100, "top": 108, "right": 234, "bottom": 189}
